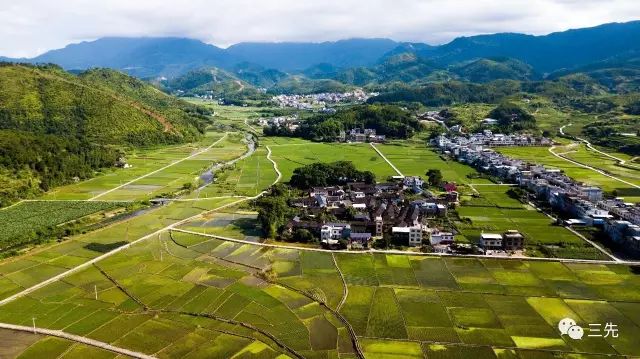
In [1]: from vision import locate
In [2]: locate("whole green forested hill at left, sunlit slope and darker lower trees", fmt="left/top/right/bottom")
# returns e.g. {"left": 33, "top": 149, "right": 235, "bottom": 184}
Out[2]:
{"left": 0, "top": 64, "right": 208, "bottom": 206}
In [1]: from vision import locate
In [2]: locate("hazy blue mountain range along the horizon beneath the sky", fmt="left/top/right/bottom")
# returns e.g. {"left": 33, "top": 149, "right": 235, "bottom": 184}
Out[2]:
{"left": 5, "top": 21, "right": 640, "bottom": 92}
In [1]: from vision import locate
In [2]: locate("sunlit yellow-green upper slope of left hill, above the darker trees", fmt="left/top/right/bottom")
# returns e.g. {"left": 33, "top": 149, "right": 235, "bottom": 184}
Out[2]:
{"left": 0, "top": 65, "right": 206, "bottom": 145}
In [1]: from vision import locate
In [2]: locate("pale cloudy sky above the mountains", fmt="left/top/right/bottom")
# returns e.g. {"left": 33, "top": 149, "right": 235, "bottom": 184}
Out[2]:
{"left": 0, "top": 0, "right": 640, "bottom": 57}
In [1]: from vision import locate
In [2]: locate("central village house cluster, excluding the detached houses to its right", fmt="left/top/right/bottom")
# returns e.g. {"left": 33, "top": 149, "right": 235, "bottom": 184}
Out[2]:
{"left": 285, "top": 177, "right": 459, "bottom": 249}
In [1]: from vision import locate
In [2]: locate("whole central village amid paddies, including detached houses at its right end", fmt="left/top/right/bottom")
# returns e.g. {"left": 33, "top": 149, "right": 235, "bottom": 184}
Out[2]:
{"left": 284, "top": 172, "right": 525, "bottom": 255}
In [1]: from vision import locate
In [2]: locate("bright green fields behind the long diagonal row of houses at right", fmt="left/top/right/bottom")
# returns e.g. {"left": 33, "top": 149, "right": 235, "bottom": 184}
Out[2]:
{"left": 498, "top": 145, "right": 640, "bottom": 202}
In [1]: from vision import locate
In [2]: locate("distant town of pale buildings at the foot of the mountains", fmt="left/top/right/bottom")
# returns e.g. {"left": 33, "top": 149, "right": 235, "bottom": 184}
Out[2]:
{"left": 272, "top": 90, "right": 378, "bottom": 112}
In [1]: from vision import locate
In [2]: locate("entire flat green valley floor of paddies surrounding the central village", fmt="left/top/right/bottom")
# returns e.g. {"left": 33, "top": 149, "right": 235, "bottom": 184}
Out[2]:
{"left": 0, "top": 114, "right": 640, "bottom": 359}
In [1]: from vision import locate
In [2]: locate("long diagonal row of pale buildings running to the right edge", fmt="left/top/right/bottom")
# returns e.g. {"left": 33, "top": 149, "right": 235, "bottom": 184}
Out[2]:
{"left": 434, "top": 134, "right": 640, "bottom": 253}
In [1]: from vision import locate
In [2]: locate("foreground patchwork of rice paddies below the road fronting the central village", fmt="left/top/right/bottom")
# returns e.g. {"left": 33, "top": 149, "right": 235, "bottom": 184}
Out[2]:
{"left": 0, "top": 231, "right": 640, "bottom": 358}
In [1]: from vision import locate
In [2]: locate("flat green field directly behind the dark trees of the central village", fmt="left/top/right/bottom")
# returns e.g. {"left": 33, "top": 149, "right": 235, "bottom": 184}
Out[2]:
{"left": 262, "top": 138, "right": 397, "bottom": 182}
